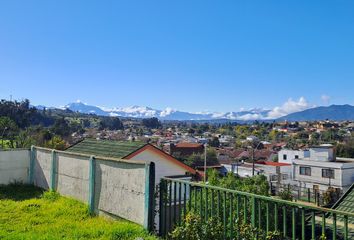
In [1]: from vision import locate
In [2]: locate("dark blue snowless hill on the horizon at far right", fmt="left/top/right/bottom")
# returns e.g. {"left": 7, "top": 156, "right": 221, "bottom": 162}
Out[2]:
{"left": 277, "top": 104, "right": 354, "bottom": 121}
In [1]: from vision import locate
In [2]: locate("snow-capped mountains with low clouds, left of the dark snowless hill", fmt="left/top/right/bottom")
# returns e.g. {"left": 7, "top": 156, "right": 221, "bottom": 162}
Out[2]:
{"left": 62, "top": 101, "right": 270, "bottom": 121}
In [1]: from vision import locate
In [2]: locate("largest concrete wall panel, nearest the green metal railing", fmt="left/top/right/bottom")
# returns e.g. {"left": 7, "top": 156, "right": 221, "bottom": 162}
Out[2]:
{"left": 95, "top": 160, "right": 146, "bottom": 224}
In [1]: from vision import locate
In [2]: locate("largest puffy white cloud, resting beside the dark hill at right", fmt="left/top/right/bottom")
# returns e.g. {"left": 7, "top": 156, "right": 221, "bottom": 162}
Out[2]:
{"left": 267, "top": 97, "right": 313, "bottom": 119}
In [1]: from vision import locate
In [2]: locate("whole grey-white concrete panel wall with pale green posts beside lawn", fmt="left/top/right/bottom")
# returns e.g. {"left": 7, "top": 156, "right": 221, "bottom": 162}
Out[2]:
{"left": 0, "top": 147, "right": 155, "bottom": 229}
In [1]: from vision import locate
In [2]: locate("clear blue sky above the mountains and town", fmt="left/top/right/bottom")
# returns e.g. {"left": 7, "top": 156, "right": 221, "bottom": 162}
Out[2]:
{"left": 0, "top": 0, "right": 354, "bottom": 111}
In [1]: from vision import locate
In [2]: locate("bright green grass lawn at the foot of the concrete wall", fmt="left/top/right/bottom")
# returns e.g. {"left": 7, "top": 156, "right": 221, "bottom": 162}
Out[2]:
{"left": 0, "top": 185, "right": 156, "bottom": 239}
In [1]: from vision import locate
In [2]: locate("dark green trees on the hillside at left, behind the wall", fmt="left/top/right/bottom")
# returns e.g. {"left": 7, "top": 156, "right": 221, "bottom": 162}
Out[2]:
{"left": 0, "top": 99, "right": 123, "bottom": 149}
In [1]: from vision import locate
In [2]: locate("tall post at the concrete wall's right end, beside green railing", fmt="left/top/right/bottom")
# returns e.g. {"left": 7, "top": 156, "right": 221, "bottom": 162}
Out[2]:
{"left": 144, "top": 162, "right": 155, "bottom": 232}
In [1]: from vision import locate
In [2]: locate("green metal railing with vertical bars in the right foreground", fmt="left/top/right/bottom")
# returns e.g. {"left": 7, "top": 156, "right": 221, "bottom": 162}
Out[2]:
{"left": 159, "top": 178, "right": 354, "bottom": 240}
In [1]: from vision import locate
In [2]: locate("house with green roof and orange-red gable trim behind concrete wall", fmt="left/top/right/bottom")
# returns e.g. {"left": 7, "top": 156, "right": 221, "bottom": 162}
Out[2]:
{"left": 66, "top": 139, "right": 196, "bottom": 184}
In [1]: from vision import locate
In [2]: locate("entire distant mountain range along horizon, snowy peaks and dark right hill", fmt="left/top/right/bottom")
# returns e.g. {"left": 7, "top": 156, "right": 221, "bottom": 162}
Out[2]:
{"left": 50, "top": 101, "right": 354, "bottom": 121}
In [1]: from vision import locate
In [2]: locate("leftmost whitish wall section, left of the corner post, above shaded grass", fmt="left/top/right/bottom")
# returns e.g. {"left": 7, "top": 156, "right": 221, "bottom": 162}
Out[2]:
{"left": 0, "top": 150, "right": 30, "bottom": 184}
